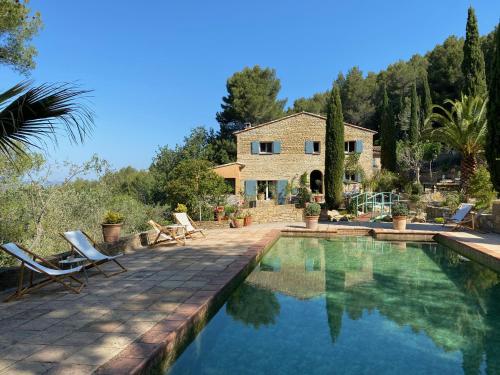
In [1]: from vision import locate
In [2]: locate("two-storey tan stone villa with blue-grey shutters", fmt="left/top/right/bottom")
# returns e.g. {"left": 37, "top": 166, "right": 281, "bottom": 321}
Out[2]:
{"left": 214, "top": 112, "right": 379, "bottom": 203}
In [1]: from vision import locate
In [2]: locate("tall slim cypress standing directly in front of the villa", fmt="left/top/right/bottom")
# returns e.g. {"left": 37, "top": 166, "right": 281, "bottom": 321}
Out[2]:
{"left": 325, "top": 85, "right": 344, "bottom": 210}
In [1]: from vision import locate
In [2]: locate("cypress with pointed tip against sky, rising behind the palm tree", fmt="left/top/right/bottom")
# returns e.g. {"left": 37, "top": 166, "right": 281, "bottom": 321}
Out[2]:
{"left": 462, "top": 7, "right": 486, "bottom": 96}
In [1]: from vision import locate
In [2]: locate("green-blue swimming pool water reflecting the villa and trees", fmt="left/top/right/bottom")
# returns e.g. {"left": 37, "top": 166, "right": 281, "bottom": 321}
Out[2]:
{"left": 167, "top": 237, "right": 500, "bottom": 375}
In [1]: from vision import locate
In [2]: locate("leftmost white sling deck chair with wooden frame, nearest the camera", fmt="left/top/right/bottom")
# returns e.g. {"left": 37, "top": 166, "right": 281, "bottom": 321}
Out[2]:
{"left": 0, "top": 242, "right": 85, "bottom": 302}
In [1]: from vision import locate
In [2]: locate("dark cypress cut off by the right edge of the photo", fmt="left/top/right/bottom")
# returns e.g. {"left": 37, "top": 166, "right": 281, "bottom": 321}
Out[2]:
{"left": 486, "top": 24, "right": 500, "bottom": 191}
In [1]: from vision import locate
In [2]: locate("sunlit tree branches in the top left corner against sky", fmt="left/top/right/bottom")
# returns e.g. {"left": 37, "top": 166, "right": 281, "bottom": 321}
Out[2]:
{"left": 0, "top": 0, "right": 43, "bottom": 73}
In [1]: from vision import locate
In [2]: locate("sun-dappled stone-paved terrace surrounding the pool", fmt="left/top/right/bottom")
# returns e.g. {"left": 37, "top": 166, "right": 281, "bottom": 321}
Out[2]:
{"left": 0, "top": 223, "right": 500, "bottom": 374}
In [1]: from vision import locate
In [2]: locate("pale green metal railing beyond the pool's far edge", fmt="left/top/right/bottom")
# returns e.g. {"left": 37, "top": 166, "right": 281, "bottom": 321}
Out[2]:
{"left": 351, "top": 192, "right": 401, "bottom": 218}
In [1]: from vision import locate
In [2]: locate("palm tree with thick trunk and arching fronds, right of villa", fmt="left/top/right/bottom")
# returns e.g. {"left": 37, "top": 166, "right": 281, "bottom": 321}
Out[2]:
{"left": 429, "top": 95, "right": 487, "bottom": 189}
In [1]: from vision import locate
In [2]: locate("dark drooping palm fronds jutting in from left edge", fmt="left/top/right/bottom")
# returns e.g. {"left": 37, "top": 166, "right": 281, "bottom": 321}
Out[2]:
{"left": 0, "top": 82, "right": 94, "bottom": 156}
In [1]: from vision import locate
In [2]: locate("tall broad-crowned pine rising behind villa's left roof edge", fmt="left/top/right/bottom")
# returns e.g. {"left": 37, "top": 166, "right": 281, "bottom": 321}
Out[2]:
{"left": 216, "top": 65, "right": 286, "bottom": 139}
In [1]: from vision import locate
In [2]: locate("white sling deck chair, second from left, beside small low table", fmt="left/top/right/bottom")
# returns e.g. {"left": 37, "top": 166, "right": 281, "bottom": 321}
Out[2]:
{"left": 62, "top": 230, "right": 127, "bottom": 277}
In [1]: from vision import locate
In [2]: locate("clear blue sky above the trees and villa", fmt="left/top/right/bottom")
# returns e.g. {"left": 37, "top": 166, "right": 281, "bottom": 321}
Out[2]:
{"left": 1, "top": 0, "right": 500, "bottom": 175}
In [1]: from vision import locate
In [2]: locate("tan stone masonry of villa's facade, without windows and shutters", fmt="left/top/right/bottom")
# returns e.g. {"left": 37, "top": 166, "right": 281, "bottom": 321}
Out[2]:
{"left": 236, "top": 113, "right": 374, "bottom": 185}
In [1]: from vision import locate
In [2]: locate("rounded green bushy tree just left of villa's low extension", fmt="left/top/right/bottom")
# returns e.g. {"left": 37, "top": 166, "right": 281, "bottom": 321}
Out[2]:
{"left": 166, "top": 159, "right": 229, "bottom": 220}
